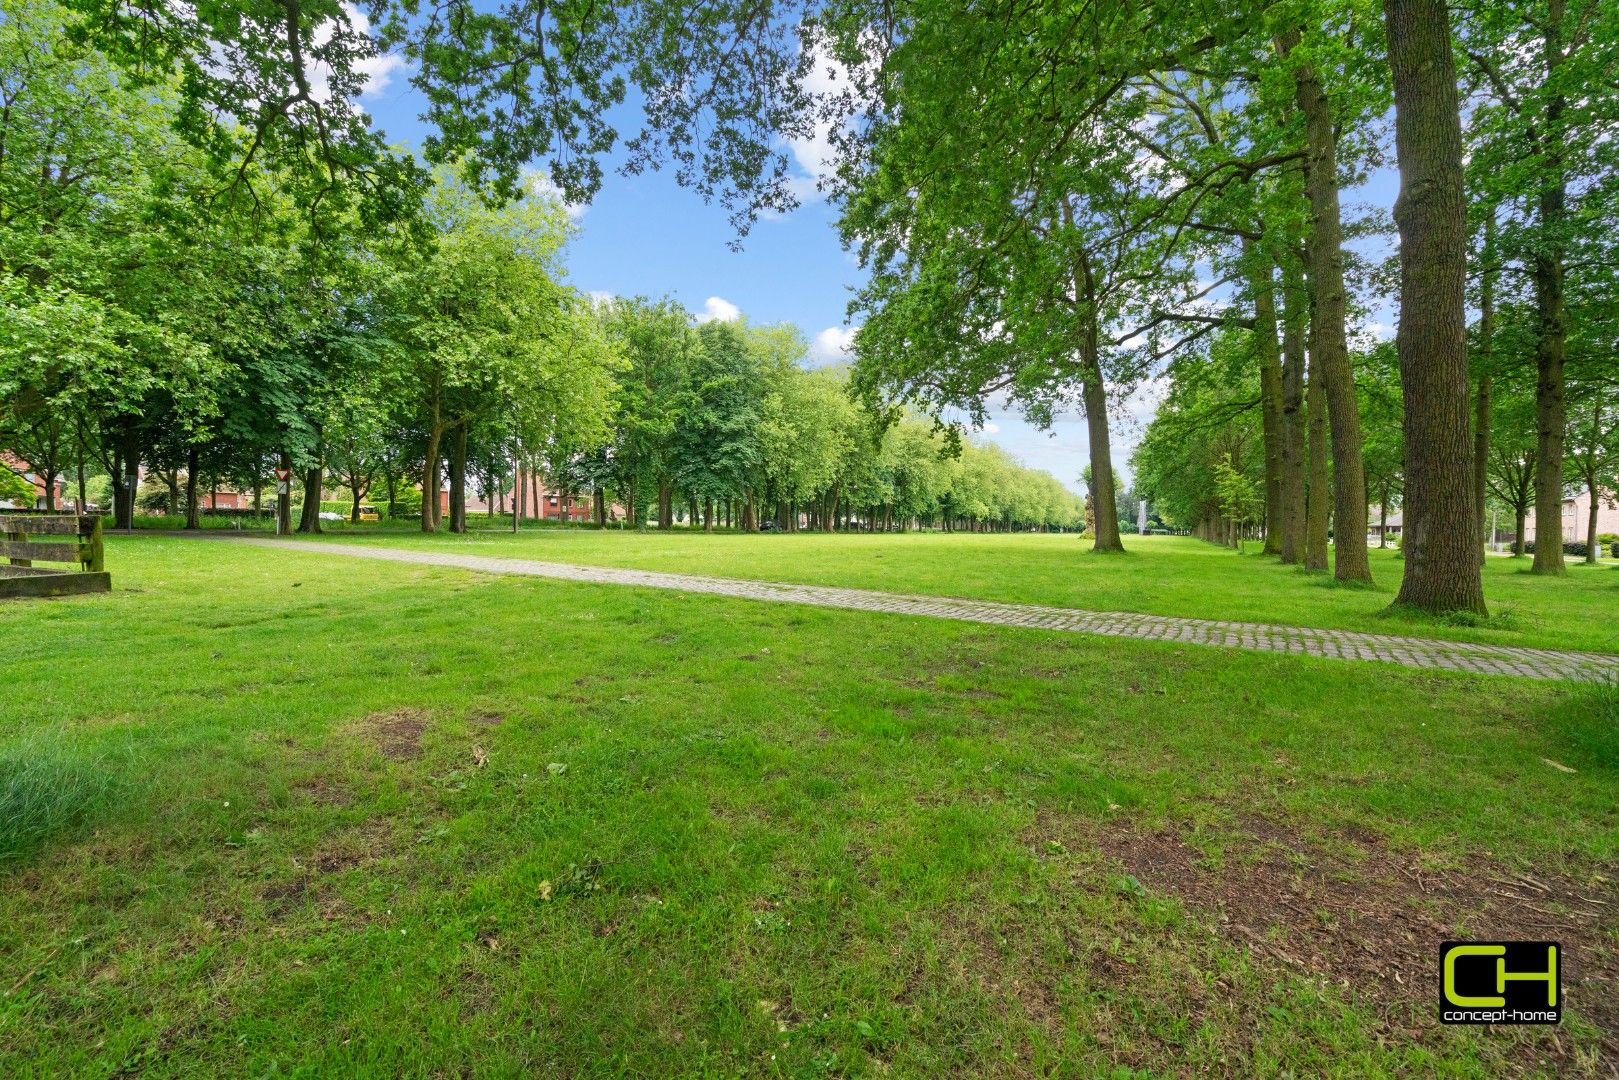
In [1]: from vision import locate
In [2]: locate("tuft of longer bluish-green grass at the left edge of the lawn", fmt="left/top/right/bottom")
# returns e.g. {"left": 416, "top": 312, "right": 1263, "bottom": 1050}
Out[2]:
{"left": 0, "top": 740, "right": 112, "bottom": 868}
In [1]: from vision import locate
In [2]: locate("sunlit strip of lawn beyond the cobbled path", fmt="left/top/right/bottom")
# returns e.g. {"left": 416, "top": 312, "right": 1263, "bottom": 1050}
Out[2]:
{"left": 312, "top": 521, "right": 1619, "bottom": 653}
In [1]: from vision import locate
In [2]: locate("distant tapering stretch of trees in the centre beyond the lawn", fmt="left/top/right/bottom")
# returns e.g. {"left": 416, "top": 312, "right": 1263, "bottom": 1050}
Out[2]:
{"left": 573, "top": 298, "right": 1083, "bottom": 529}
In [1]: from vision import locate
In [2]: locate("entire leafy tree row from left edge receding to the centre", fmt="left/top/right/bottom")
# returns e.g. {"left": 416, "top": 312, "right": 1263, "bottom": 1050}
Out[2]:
{"left": 0, "top": 0, "right": 1081, "bottom": 531}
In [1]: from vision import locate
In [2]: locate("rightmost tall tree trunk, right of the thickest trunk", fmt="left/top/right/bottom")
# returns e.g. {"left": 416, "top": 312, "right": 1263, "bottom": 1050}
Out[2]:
{"left": 1530, "top": 0, "right": 1569, "bottom": 573}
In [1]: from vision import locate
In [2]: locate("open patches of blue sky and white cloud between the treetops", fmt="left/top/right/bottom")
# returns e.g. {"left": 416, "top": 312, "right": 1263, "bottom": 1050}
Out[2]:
{"left": 361, "top": 28, "right": 1397, "bottom": 492}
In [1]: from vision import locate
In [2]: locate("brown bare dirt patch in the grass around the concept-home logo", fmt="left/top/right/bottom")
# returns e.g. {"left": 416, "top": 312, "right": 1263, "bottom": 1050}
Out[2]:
{"left": 1075, "top": 819, "right": 1619, "bottom": 1057}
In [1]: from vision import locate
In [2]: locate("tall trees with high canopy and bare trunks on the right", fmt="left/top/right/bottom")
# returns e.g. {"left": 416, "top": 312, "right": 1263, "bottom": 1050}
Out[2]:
{"left": 803, "top": 0, "right": 1619, "bottom": 612}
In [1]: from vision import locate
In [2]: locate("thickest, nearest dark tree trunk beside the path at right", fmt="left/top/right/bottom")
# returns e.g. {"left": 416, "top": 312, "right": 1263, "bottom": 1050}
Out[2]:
{"left": 1385, "top": 0, "right": 1485, "bottom": 614}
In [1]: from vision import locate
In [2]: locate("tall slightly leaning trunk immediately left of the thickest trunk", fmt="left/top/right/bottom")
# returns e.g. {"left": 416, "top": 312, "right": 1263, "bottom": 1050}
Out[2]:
{"left": 1277, "top": 31, "right": 1371, "bottom": 583}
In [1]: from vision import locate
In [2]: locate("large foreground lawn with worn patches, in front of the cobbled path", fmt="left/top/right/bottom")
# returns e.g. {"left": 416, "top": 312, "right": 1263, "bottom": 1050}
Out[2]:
{"left": 0, "top": 534, "right": 1619, "bottom": 1077}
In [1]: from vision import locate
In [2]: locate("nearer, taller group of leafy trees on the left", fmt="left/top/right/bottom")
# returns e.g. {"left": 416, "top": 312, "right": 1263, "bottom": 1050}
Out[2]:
{"left": 0, "top": 0, "right": 617, "bottom": 529}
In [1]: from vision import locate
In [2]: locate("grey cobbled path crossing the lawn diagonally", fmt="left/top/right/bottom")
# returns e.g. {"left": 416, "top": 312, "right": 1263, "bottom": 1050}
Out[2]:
{"left": 236, "top": 538, "right": 1619, "bottom": 682}
